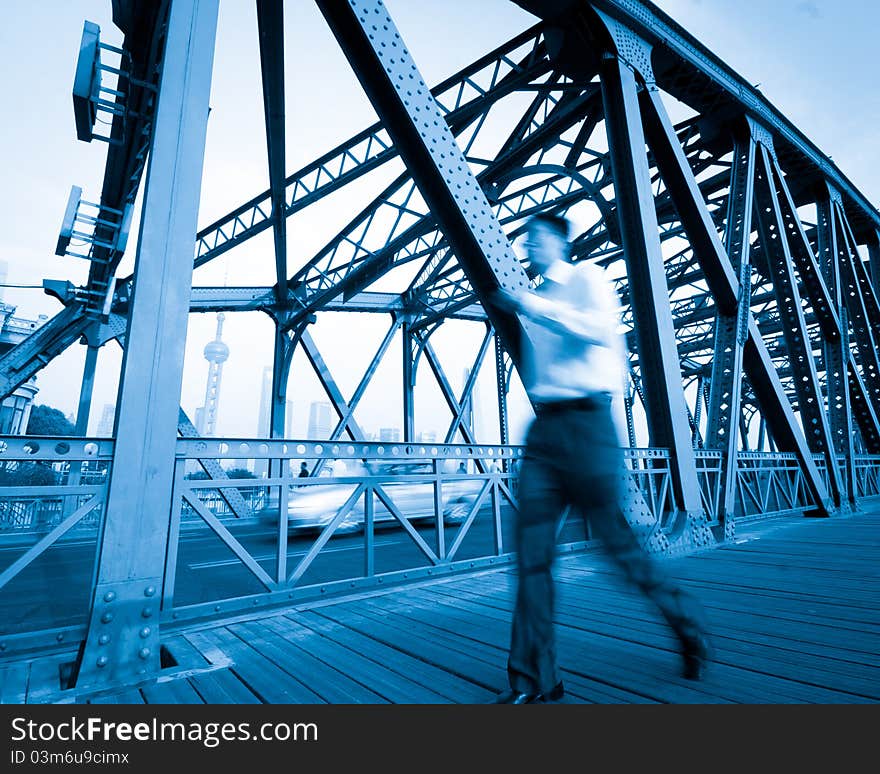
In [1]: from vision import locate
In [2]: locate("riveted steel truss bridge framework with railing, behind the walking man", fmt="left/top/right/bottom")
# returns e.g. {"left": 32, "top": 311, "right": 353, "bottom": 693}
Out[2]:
{"left": 0, "top": 0, "right": 880, "bottom": 704}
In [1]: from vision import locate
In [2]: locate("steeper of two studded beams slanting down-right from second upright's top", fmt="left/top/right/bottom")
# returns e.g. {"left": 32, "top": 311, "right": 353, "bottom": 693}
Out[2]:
{"left": 755, "top": 140, "right": 844, "bottom": 508}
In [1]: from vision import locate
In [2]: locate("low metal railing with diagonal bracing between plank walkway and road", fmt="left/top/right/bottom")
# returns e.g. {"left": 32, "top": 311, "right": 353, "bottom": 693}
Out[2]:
{"left": 0, "top": 436, "right": 880, "bottom": 655}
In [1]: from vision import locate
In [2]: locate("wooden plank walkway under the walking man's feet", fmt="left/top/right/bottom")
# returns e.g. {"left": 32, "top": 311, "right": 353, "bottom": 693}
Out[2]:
{"left": 6, "top": 503, "right": 880, "bottom": 704}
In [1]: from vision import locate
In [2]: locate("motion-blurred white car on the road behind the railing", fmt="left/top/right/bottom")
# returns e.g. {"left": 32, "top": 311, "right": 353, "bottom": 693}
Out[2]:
{"left": 278, "top": 462, "right": 483, "bottom": 534}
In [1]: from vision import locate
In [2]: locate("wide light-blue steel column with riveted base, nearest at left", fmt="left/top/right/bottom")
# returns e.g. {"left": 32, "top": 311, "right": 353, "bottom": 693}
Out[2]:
{"left": 72, "top": 0, "right": 218, "bottom": 689}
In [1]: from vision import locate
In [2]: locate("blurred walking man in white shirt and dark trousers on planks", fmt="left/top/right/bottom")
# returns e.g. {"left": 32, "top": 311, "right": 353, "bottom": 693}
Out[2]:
{"left": 496, "top": 215, "right": 709, "bottom": 704}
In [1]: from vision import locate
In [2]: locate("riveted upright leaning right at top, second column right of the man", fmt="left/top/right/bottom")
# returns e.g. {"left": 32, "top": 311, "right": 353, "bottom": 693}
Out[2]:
{"left": 706, "top": 133, "right": 763, "bottom": 538}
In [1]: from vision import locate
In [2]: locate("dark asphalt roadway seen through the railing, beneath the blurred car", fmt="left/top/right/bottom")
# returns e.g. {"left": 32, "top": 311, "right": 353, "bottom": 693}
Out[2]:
{"left": 0, "top": 506, "right": 583, "bottom": 634}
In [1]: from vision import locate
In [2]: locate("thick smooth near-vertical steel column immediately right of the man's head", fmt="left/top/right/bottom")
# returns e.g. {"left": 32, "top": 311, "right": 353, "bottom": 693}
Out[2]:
{"left": 601, "top": 54, "right": 703, "bottom": 514}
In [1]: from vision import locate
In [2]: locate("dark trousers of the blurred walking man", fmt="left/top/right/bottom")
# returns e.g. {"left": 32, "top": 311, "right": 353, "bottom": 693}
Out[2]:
{"left": 507, "top": 396, "right": 702, "bottom": 694}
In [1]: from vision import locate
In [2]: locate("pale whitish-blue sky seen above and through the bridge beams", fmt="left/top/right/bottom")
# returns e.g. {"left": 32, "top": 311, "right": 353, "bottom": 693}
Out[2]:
{"left": 0, "top": 0, "right": 880, "bottom": 441}
